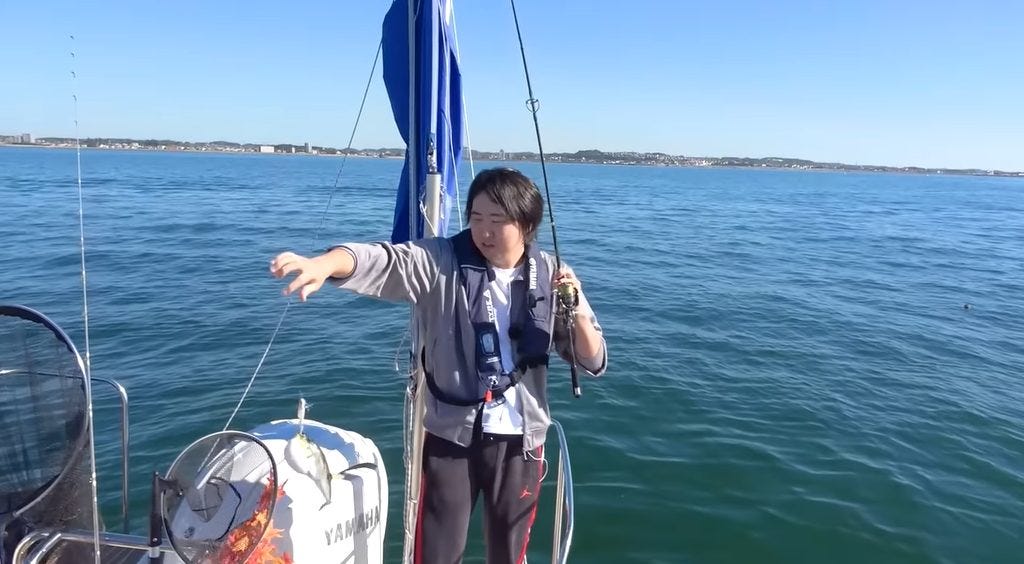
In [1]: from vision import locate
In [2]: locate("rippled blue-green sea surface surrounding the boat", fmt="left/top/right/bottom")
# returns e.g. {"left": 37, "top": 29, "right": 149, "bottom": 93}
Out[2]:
{"left": 0, "top": 147, "right": 1024, "bottom": 563}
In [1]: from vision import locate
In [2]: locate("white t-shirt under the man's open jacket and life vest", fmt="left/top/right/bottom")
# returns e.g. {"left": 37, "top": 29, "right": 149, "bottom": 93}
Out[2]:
{"left": 481, "top": 266, "right": 522, "bottom": 435}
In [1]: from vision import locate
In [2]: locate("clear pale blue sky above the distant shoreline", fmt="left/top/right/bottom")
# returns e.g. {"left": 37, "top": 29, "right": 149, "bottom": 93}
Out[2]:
{"left": 0, "top": 0, "right": 1024, "bottom": 171}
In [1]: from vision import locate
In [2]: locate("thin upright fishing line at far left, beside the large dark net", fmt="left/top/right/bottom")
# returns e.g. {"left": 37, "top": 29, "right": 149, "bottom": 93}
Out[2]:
{"left": 69, "top": 35, "right": 99, "bottom": 564}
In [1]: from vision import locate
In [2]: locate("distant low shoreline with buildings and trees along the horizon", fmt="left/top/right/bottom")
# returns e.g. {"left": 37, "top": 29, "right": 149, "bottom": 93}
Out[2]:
{"left": 0, "top": 137, "right": 1024, "bottom": 178}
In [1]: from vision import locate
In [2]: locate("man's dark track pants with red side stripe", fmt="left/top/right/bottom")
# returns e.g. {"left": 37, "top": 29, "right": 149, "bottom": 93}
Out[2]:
{"left": 415, "top": 433, "right": 544, "bottom": 564}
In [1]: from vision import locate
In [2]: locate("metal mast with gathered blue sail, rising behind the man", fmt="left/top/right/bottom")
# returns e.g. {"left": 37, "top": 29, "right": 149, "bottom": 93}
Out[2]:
{"left": 382, "top": 0, "right": 463, "bottom": 563}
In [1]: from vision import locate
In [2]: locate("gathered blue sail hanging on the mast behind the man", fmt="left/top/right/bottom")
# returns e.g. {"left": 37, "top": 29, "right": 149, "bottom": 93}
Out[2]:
{"left": 383, "top": 0, "right": 463, "bottom": 243}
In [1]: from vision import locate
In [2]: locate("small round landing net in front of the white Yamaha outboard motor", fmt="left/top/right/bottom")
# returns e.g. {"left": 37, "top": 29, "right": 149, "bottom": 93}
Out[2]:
{"left": 162, "top": 431, "right": 278, "bottom": 564}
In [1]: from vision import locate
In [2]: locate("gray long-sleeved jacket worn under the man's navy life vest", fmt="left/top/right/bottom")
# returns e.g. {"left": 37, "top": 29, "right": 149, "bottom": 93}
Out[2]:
{"left": 330, "top": 238, "right": 607, "bottom": 449}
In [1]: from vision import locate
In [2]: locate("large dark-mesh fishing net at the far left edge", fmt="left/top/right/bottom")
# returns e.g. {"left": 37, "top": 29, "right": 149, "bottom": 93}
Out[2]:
{"left": 0, "top": 305, "right": 95, "bottom": 562}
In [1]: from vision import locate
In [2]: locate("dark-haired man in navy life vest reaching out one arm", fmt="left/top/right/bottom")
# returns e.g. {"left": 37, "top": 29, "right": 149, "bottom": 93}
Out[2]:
{"left": 270, "top": 169, "right": 607, "bottom": 564}
